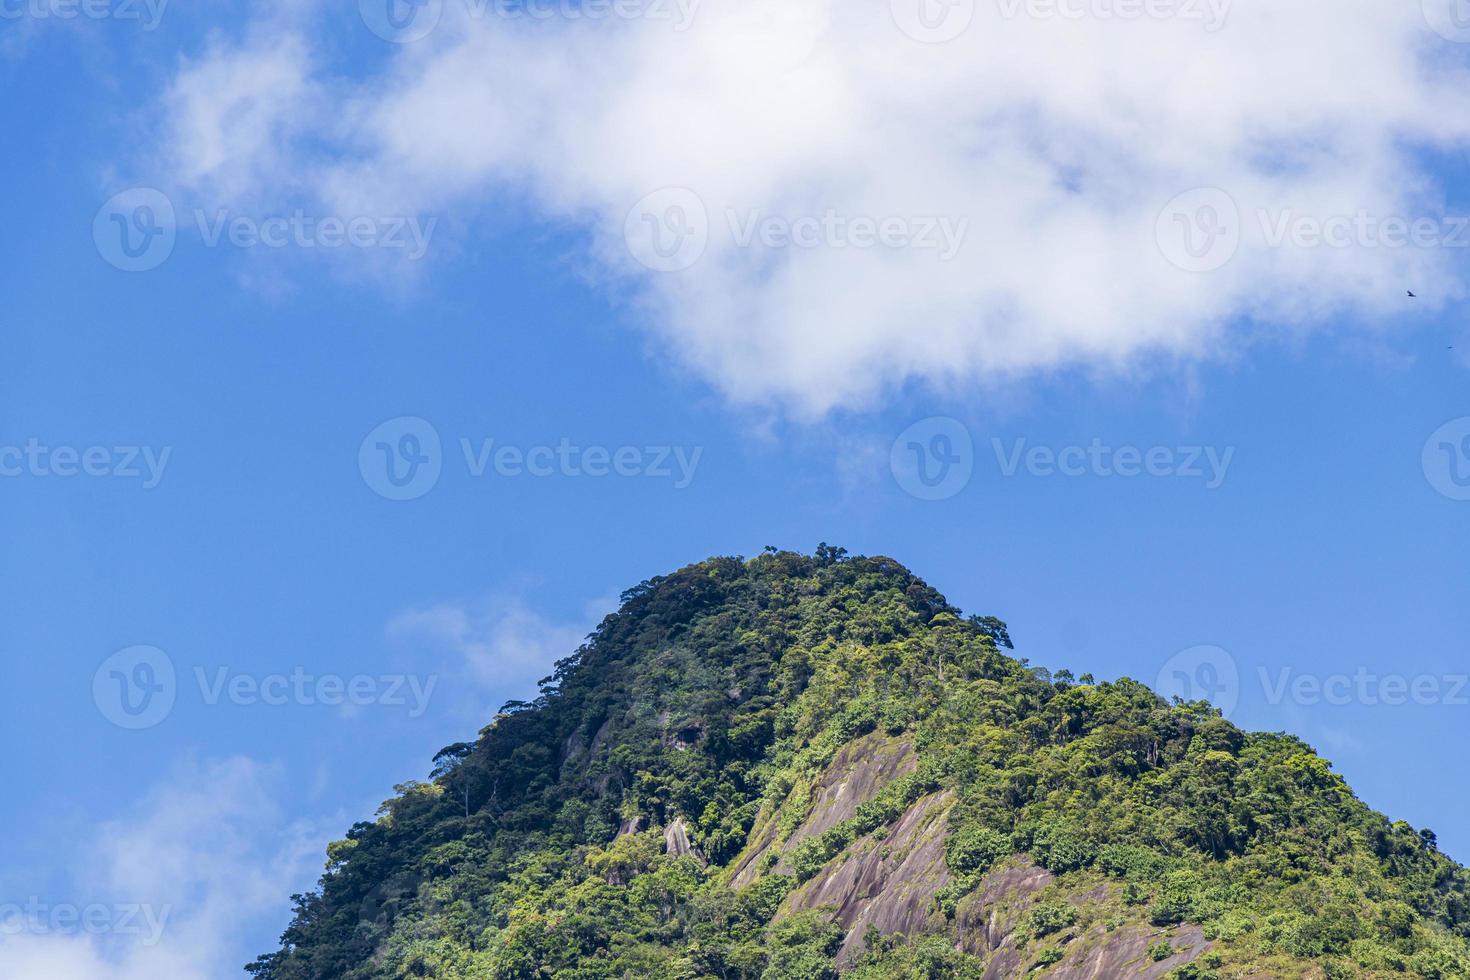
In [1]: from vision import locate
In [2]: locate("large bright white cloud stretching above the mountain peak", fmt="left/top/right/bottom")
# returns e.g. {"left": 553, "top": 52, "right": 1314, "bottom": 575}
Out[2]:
{"left": 158, "top": 0, "right": 1470, "bottom": 414}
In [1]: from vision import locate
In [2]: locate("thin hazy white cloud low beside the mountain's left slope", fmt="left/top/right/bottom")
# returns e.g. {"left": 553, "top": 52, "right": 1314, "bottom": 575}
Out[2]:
{"left": 0, "top": 757, "right": 338, "bottom": 980}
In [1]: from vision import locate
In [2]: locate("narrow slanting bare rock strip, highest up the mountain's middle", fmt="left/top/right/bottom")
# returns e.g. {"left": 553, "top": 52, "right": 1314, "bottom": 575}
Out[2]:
{"left": 731, "top": 732, "right": 917, "bottom": 887}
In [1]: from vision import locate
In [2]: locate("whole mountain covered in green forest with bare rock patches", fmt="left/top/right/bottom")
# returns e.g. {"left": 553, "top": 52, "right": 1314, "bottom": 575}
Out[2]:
{"left": 247, "top": 545, "right": 1470, "bottom": 980}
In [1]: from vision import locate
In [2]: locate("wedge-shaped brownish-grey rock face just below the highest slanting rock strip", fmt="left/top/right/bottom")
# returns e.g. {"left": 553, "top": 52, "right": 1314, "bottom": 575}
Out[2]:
{"left": 786, "top": 790, "right": 954, "bottom": 967}
